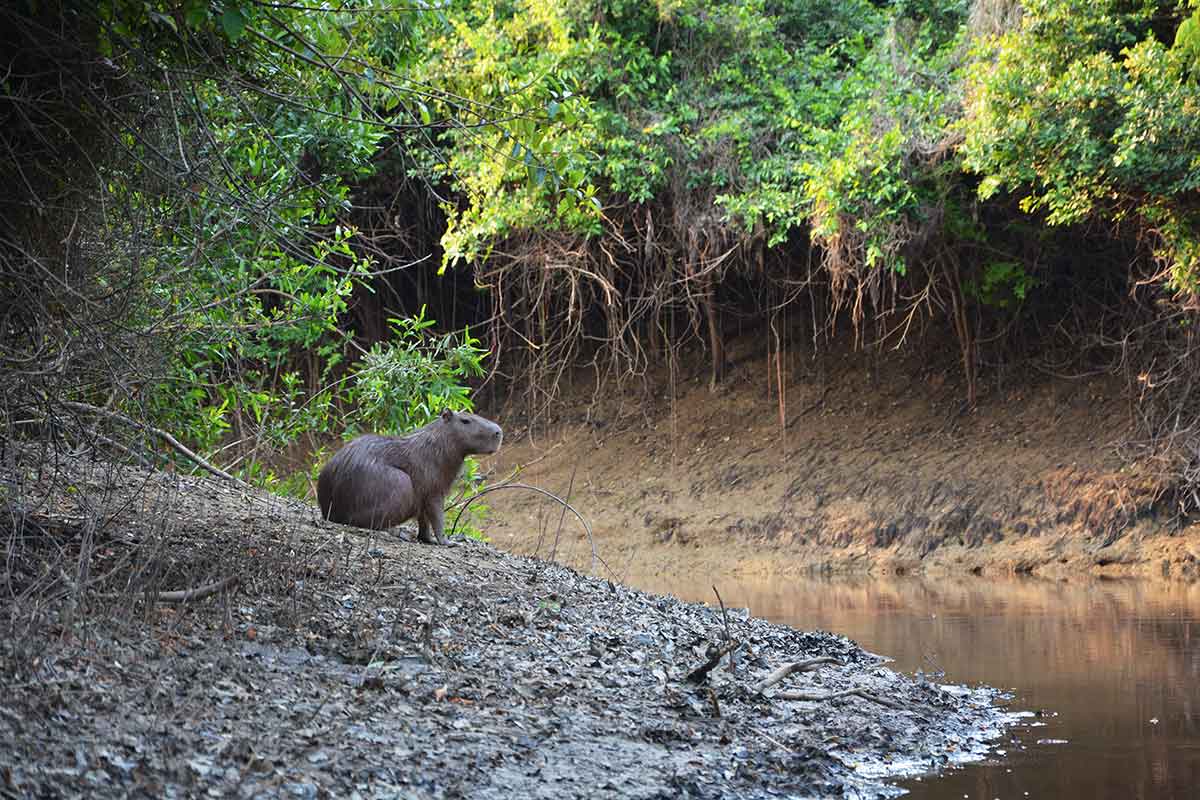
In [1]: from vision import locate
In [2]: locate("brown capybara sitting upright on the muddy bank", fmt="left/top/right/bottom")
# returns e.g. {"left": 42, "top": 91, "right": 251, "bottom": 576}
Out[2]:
{"left": 317, "top": 409, "right": 504, "bottom": 545}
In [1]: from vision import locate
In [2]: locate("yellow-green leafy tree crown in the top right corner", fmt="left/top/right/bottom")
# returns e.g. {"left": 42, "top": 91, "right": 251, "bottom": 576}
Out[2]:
{"left": 961, "top": 0, "right": 1200, "bottom": 293}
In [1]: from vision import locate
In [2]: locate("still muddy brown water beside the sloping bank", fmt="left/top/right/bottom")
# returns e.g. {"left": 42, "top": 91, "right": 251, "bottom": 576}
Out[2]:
{"left": 626, "top": 576, "right": 1200, "bottom": 800}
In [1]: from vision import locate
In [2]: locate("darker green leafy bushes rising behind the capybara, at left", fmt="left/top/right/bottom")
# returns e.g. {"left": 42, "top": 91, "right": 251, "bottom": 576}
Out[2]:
{"left": 23, "top": 0, "right": 513, "bottom": 501}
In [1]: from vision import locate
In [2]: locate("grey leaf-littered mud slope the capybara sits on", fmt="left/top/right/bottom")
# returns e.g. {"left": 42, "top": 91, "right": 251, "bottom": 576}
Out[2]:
{"left": 0, "top": 455, "right": 1003, "bottom": 798}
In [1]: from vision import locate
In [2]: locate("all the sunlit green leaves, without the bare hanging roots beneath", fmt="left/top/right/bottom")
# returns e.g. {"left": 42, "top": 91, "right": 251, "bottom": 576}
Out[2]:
{"left": 21, "top": 0, "right": 1200, "bottom": 506}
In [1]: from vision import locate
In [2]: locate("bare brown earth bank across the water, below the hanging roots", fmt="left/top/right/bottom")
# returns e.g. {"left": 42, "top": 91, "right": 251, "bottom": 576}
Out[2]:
{"left": 486, "top": 331, "right": 1200, "bottom": 585}
